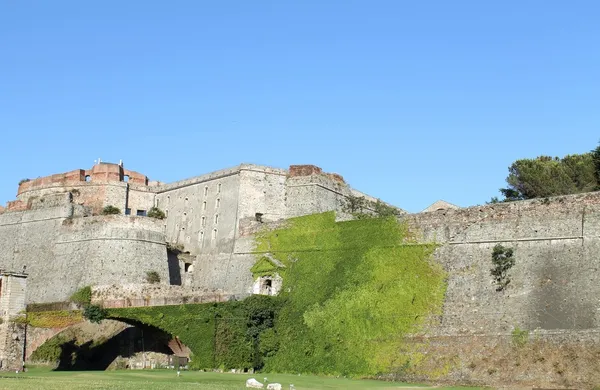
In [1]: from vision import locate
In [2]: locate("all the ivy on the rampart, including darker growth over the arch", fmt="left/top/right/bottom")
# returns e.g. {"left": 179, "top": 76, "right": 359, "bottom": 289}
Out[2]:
{"left": 42, "top": 213, "right": 446, "bottom": 376}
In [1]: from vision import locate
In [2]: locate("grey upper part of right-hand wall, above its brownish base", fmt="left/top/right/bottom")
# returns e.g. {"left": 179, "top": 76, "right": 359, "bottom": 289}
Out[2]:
{"left": 407, "top": 193, "right": 600, "bottom": 333}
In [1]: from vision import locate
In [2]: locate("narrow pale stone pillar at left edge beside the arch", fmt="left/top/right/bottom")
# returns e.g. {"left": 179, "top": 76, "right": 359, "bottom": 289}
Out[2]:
{"left": 0, "top": 271, "right": 27, "bottom": 370}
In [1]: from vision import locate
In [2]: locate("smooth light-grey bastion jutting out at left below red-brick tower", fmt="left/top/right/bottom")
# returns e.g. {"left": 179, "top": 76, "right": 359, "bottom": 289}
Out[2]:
{"left": 47, "top": 215, "right": 169, "bottom": 302}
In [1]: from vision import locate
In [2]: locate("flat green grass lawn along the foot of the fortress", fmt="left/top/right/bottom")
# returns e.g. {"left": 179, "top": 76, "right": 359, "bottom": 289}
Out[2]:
{"left": 0, "top": 367, "right": 480, "bottom": 390}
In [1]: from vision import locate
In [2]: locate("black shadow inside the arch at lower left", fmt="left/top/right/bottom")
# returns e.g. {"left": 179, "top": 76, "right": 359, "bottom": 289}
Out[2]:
{"left": 54, "top": 326, "right": 173, "bottom": 371}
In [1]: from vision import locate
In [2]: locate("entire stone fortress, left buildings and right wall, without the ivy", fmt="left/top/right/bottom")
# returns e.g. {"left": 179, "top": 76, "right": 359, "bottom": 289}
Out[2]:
{"left": 0, "top": 163, "right": 600, "bottom": 383}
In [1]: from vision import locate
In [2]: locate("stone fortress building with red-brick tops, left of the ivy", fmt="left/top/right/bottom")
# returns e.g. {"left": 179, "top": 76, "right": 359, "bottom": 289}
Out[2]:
{"left": 0, "top": 162, "right": 398, "bottom": 302}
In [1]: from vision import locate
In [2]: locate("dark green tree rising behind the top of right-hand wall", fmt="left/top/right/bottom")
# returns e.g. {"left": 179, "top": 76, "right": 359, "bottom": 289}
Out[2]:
{"left": 500, "top": 150, "right": 600, "bottom": 201}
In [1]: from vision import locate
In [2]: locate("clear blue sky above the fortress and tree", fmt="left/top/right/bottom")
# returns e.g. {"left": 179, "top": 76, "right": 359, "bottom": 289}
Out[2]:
{"left": 0, "top": 0, "right": 600, "bottom": 212}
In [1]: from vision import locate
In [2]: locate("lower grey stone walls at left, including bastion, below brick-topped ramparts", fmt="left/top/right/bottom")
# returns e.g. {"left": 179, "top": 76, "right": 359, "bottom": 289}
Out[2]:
{"left": 0, "top": 205, "right": 169, "bottom": 302}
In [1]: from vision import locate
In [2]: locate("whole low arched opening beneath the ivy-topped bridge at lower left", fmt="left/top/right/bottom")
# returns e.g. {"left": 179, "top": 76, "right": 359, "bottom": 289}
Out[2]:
{"left": 30, "top": 320, "right": 190, "bottom": 371}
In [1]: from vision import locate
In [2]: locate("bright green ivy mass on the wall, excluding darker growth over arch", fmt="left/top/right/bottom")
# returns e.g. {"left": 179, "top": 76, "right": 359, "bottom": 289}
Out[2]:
{"left": 256, "top": 213, "right": 446, "bottom": 375}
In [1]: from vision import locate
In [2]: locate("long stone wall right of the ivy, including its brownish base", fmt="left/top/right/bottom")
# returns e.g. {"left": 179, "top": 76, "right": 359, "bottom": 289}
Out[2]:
{"left": 405, "top": 192, "right": 600, "bottom": 387}
